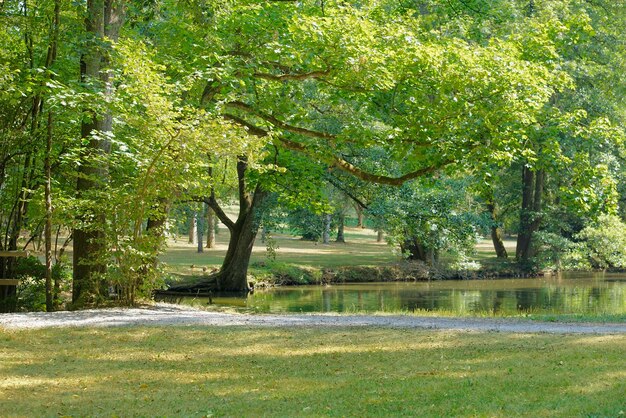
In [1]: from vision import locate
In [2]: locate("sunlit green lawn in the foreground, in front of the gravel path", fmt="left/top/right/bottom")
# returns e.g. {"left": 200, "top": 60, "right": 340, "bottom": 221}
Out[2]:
{"left": 0, "top": 327, "right": 626, "bottom": 417}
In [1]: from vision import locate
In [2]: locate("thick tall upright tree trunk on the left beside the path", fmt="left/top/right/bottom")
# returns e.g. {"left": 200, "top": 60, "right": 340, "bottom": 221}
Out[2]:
{"left": 72, "top": 0, "right": 124, "bottom": 305}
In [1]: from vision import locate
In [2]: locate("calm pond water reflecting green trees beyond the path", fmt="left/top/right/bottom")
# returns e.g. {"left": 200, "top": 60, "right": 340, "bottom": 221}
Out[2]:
{"left": 162, "top": 274, "right": 626, "bottom": 315}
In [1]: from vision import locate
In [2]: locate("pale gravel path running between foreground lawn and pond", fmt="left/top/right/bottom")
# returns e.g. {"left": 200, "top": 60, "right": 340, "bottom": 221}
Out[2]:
{"left": 0, "top": 303, "right": 626, "bottom": 334}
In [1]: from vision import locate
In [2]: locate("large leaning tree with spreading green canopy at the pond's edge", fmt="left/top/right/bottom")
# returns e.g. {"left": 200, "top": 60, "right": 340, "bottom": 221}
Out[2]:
{"left": 155, "top": 2, "right": 566, "bottom": 290}
